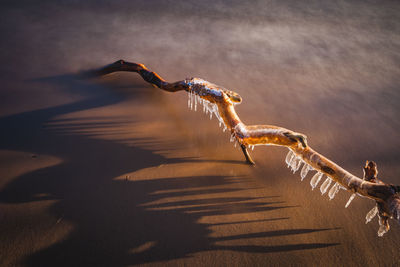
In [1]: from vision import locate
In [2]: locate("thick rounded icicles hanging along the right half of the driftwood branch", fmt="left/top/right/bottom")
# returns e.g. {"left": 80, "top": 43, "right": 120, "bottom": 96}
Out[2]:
{"left": 285, "top": 149, "right": 387, "bottom": 236}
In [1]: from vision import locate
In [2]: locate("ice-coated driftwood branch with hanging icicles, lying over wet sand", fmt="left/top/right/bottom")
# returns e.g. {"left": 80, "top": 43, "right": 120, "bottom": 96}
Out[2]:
{"left": 91, "top": 60, "right": 400, "bottom": 236}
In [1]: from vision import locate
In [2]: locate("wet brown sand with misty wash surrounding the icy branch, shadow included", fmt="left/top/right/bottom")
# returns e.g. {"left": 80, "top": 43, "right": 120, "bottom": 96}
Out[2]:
{"left": 0, "top": 1, "right": 400, "bottom": 266}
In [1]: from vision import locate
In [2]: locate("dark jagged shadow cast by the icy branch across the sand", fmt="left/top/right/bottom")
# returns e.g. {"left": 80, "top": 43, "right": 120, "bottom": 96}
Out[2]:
{"left": 0, "top": 70, "right": 338, "bottom": 266}
